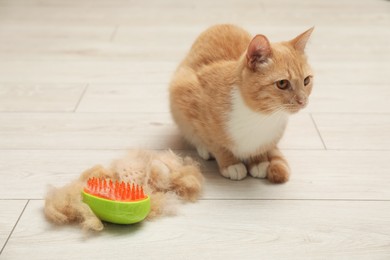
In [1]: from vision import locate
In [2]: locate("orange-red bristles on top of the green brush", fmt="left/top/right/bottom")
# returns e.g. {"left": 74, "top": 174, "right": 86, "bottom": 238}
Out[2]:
{"left": 84, "top": 177, "right": 147, "bottom": 201}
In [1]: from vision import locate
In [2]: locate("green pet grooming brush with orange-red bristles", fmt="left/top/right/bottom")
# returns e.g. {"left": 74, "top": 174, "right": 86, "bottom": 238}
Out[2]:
{"left": 82, "top": 178, "right": 150, "bottom": 224}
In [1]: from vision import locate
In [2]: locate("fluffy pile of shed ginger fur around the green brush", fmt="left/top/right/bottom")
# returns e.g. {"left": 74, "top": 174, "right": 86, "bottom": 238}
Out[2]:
{"left": 44, "top": 150, "right": 204, "bottom": 231}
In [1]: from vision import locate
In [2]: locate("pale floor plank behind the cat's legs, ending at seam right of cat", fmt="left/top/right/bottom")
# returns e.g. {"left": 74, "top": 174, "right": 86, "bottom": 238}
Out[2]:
{"left": 0, "top": 113, "right": 323, "bottom": 150}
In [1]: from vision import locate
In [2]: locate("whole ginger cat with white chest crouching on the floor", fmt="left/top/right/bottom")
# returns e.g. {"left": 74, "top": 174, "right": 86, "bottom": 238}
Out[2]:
{"left": 170, "top": 25, "right": 313, "bottom": 183}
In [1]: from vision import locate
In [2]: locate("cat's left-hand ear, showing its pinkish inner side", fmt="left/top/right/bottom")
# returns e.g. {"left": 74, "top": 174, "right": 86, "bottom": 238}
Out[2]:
{"left": 246, "top": 34, "right": 271, "bottom": 71}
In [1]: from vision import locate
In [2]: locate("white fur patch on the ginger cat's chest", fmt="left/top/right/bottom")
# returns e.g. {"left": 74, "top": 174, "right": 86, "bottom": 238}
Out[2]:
{"left": 226, "top": 86, "right": 289, "bottom": 159}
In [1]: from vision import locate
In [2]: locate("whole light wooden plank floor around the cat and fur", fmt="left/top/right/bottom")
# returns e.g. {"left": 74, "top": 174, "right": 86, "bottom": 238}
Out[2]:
{"left": 0, "top": 0, "right": 390, "bottom": 259}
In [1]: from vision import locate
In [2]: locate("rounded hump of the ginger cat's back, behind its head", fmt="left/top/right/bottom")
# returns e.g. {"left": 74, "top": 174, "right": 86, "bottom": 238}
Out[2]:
{"left": 183, "top": 24, "right": 251, "bottom": 70}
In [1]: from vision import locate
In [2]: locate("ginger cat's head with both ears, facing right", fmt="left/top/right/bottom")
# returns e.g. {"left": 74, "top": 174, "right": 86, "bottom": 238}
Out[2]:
{"left": 240, "top": 28, "right": 314, "bottom": 113}
